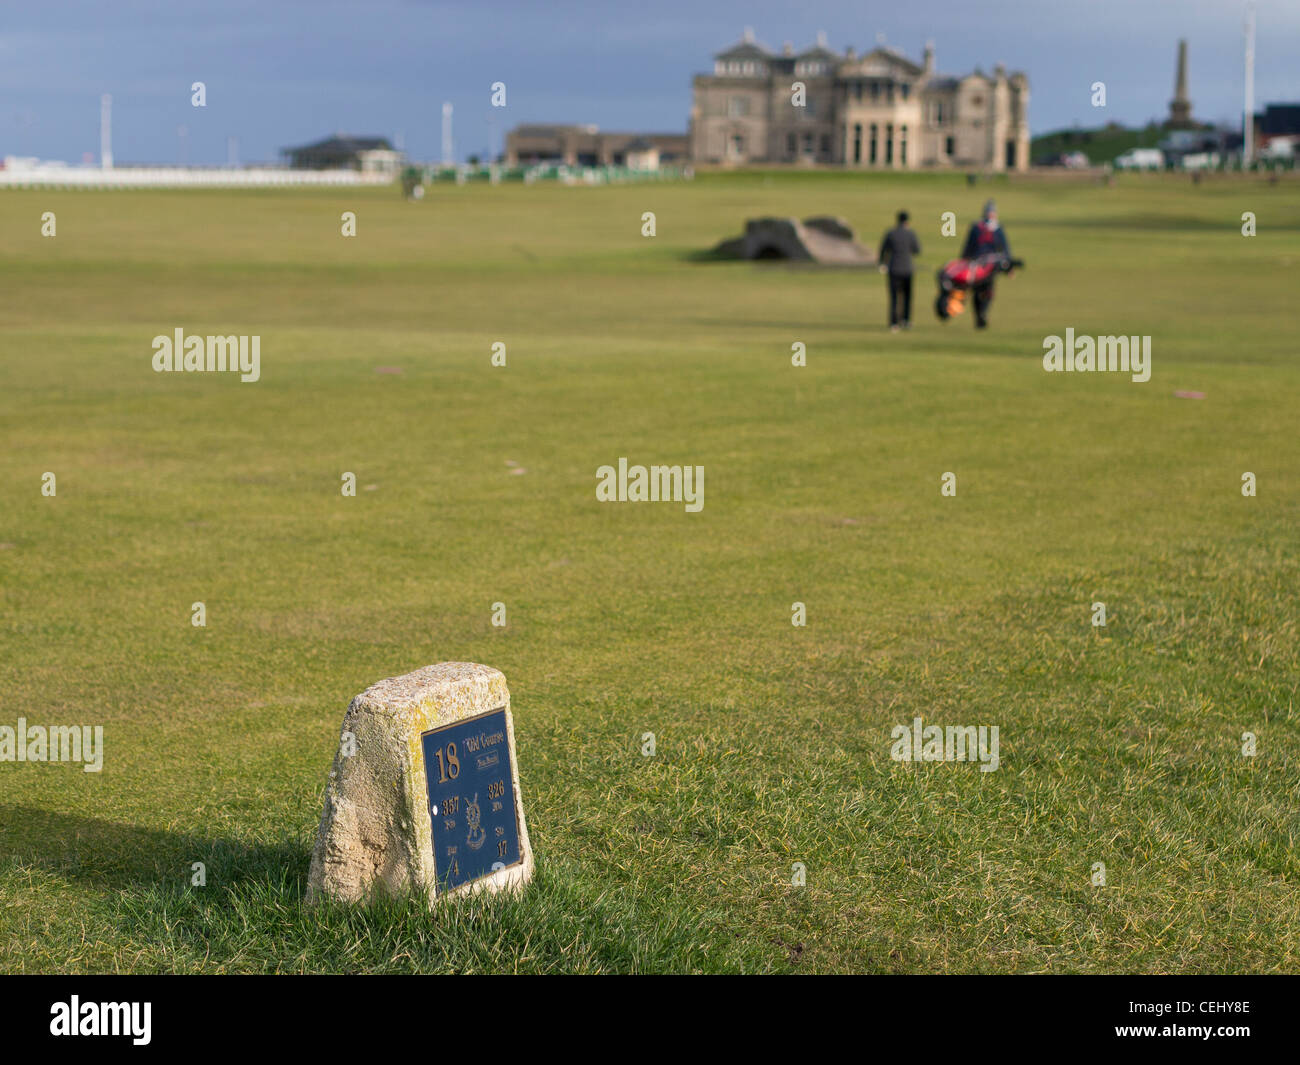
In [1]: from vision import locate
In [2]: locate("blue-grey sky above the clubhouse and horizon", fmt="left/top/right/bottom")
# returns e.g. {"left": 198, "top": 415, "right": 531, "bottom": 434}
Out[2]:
{"left": 0, "top": 0, "right": 1300, "bottom": 164}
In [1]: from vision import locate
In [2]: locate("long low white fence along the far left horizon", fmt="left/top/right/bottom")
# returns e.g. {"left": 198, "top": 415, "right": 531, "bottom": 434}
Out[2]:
{"left": 0, "top": 165, "right": 397, "bottom": 189}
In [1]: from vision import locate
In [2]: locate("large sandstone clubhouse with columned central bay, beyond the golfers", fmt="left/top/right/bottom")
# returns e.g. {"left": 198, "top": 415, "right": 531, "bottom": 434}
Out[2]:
{"left": 690, "top": 30, "right": 1030, "bottom": 170}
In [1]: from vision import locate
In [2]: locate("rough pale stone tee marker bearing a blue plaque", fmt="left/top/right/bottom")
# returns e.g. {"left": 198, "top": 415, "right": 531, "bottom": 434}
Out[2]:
{"left": 307, "top": 662, "right": 533, "bottom": 905}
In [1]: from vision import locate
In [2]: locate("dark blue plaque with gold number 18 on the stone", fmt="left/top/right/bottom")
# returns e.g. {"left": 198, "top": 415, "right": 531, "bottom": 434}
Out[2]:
{"left": 420, "top": 707, "right": 523, "bottom": 892}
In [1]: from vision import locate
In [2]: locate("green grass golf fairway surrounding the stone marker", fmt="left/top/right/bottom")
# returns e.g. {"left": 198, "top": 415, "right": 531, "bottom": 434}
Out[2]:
{"left": 0, "top": 173, "right": 1300, "bottom": 973}
